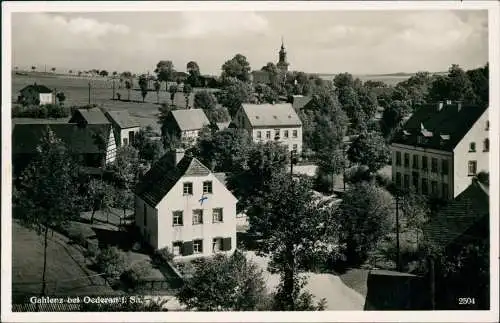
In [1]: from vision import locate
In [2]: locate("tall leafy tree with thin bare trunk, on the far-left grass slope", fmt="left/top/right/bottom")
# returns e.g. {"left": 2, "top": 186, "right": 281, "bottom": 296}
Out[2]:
{"left": 13, "top": 128, "right": 78, "bottom": 295}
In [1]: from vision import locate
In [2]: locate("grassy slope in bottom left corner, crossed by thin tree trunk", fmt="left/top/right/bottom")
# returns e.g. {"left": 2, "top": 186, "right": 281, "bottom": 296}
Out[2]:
{"left": 12, "top": 221, "right": 112, "bottom": 295}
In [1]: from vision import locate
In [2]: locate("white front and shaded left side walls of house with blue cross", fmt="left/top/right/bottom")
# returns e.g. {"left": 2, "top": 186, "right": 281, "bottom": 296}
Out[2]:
{"left": 135, "top": 173, "right": 237, "bottom": 257}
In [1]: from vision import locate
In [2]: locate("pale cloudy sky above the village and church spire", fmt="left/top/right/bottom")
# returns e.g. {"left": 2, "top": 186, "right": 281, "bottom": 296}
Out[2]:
{"left": 12, "top": 10, "right": 488, "bottom": 75}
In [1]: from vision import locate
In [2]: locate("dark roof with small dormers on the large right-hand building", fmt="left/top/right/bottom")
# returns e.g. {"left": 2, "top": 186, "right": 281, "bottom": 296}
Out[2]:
{"left": 392, "top": 104, "right": 487, "bottom": 151}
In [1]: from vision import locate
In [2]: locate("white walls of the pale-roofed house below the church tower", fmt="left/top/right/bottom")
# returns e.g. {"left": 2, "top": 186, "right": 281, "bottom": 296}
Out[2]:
{"left": 233, "top": 109, "right": 302, "bottom": 154}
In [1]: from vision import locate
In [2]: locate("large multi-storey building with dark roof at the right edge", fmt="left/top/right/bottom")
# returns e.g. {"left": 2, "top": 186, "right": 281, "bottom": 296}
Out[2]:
{"left": 391, "top": 101, "right": 490, "bottom": 199}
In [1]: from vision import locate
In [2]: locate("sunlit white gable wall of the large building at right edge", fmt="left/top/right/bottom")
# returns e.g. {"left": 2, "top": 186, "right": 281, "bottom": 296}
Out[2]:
{"left": 453, "top": 110, "right": 490, "bottom": 197}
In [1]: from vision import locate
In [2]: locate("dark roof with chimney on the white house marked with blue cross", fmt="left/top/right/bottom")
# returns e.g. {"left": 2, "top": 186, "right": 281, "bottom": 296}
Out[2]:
{"left": 135, "top": 154, "right": 210, "bottom": 207}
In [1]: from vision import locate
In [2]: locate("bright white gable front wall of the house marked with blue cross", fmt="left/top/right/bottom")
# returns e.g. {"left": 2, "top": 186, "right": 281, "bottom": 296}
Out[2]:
{"left": 157, "top": 174, "right": 236, "bottom": 256}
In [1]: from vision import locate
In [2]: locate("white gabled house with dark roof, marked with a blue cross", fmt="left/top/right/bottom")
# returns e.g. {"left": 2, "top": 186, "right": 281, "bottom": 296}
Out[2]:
{"left": 135, "top": 149, "right": 237, "bottom": 256}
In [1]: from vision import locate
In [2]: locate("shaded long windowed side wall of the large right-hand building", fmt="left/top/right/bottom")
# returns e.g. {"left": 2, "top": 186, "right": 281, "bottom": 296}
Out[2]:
{"left": 391, "top": 144, "right": 453, "bottom": 198}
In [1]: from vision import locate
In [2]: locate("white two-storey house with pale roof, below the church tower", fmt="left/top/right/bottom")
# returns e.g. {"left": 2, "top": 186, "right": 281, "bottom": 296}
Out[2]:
{"left": 232, "top": 103, "right": 302, "bottom": 153}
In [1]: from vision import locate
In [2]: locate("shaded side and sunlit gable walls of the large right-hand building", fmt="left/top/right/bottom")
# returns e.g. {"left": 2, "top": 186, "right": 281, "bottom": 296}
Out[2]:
{"left": 391, "top": 110, "right": 489, "bottom": 199}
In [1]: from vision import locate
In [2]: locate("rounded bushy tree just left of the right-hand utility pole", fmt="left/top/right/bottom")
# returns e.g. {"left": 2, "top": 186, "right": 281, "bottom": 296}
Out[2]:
{"left": 336, "top": 182, "right": 393, "bottom": 265}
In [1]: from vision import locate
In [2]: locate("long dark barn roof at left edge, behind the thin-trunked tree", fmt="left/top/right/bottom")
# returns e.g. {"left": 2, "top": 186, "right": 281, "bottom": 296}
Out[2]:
{"left": 12, "top": 123, "right": 111, "bottom": 154}
